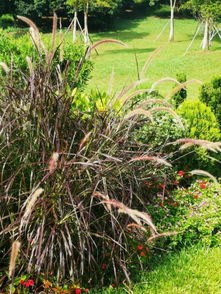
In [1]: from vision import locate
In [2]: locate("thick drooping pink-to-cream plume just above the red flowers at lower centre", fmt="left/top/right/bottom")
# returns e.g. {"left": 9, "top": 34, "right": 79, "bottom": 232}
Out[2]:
{"left": 101, "top": 199, "right": 157, "bottom": 234}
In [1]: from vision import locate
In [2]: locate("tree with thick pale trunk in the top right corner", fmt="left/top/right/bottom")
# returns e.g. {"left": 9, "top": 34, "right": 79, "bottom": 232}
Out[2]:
{"left": 183, "top": 0, "right": 221, "bottom": 51}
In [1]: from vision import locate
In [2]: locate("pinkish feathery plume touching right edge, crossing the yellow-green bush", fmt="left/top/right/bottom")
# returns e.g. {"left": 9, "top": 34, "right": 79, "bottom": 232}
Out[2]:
{"left": 173, "top": 138, "right": 221, "bottom": 153}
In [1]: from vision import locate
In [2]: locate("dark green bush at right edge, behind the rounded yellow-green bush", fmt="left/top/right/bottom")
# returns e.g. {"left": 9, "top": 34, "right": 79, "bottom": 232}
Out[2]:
{"left": 200, "top": 77, "right": 221, "bottom": 126}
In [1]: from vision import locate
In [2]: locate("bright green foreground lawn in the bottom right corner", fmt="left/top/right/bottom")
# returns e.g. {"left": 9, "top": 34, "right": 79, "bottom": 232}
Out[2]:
{"left": 96, "top": 248, "right": 221, "bottom": 294}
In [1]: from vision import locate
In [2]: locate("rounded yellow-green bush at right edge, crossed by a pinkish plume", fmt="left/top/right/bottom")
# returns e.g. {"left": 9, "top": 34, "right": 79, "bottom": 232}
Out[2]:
{"left": 176, "top": 100, "right": 220, "bottom": 175}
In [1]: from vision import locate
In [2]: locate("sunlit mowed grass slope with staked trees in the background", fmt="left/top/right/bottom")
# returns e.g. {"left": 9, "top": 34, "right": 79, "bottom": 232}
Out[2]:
{"left": 88, "top": 5, "right": 221, "bottom": 98}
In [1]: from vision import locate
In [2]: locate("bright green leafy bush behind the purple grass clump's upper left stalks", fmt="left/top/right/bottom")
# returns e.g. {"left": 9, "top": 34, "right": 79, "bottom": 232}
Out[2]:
{"left": 0, "top": 30, "right": 93, "bottom": 90}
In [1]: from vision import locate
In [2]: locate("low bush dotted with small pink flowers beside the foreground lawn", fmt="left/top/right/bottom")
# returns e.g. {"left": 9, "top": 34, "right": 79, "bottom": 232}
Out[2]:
{"left": 148, "top": 178, "right": 221, "bottom": 248}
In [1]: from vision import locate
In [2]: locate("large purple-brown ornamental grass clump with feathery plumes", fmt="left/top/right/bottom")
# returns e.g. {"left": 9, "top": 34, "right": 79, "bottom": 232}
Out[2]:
{"left": 0, "top": 17, "right": 219, "bottom": 287}
